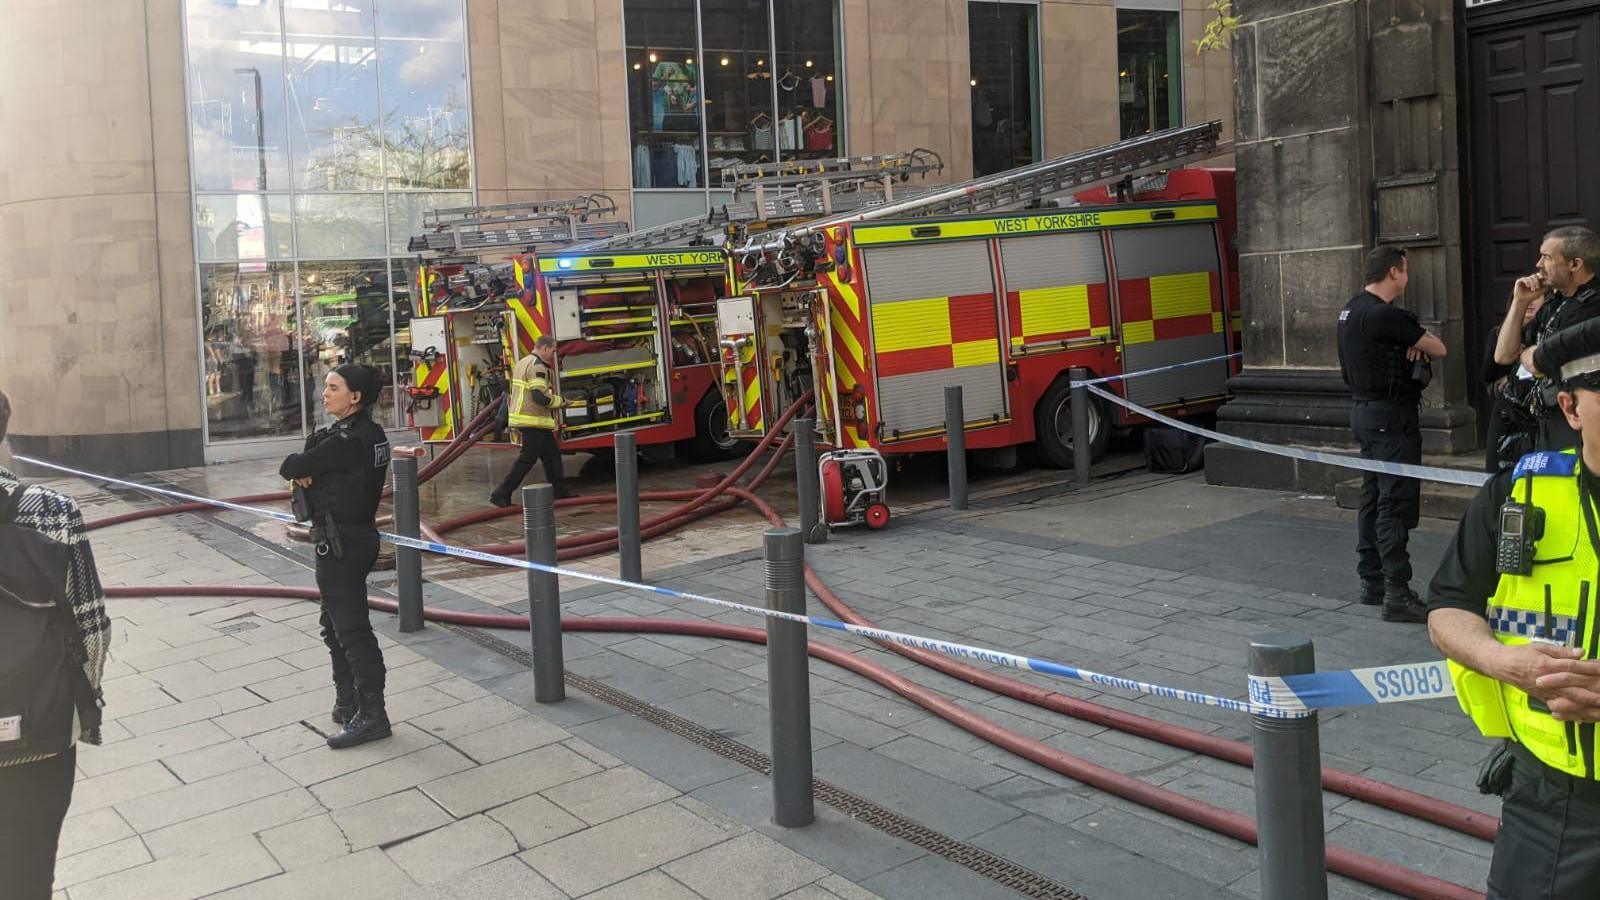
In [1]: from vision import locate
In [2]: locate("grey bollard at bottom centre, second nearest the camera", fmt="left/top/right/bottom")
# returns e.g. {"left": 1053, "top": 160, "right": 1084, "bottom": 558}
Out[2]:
{"left": 765, "top": 528, "right": 816, "bottom": 828}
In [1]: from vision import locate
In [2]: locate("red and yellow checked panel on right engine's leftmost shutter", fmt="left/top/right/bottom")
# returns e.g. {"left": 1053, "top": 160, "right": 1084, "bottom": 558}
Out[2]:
{"left": 872, "top": 293, "right": 1000, "bottom": 378}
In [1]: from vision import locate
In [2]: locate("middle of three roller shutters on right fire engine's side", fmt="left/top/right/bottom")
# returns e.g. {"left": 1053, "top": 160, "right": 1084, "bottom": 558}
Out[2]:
{"left": 1000, "top": 231, "right": 1110, "bottom": 348}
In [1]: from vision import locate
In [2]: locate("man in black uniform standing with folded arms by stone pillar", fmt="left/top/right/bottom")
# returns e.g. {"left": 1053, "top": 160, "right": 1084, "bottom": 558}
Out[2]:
{"left": 1339, "top": 247, "right": 1445, "bottom": 621}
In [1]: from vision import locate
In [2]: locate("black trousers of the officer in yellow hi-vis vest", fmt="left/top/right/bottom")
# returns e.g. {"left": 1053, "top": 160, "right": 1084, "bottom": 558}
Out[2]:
{"left": 1488, "top": 748, "right": 1600, "bottom": 900}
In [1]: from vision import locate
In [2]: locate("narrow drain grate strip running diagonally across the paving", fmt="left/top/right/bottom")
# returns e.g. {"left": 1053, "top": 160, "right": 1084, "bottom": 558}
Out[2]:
{"left": 446, "top": 626, "right": 1088, "bottom": 900}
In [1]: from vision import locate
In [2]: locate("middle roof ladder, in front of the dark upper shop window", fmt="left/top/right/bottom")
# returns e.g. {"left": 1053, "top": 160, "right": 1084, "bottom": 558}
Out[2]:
{"left": 570, "top": 147, "right": 944, "bottom": 251}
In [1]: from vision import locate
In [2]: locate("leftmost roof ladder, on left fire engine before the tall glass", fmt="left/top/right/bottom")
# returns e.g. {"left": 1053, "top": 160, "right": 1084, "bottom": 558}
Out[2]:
{"left": 408, "top": 194, "right": 627, "bottom": 256}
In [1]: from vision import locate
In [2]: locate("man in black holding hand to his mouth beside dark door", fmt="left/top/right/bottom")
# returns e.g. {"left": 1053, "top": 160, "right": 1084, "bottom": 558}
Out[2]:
{"left": 1494, "top": 226, "right": 1600, "bottom": 450}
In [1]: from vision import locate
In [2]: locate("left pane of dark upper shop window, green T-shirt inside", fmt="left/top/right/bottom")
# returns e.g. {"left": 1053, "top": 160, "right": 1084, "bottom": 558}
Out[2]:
{"left": 622, "top": 0, "right": 704, "bottom": 187}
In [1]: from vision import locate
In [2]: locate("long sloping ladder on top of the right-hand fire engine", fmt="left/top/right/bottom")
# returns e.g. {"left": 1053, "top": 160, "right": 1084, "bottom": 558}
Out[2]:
{"left": 738, "top": 122, "right": 1232, "bottom": 255}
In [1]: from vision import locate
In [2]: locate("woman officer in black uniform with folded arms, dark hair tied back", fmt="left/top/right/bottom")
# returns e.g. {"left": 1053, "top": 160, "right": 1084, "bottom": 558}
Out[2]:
{"left": 278, "top": 365, "right": 389, "bottom": 749}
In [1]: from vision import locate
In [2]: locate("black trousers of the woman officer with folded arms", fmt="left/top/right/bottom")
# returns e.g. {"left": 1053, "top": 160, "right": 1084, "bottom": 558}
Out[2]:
{"left": 317, "top": 525, "right": 384, "bottom": 690}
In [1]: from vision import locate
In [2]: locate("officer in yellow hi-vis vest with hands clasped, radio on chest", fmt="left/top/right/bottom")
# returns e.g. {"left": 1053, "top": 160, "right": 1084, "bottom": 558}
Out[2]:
{"left": 1427, "top": 318, "right": 1600, "bottom": 900}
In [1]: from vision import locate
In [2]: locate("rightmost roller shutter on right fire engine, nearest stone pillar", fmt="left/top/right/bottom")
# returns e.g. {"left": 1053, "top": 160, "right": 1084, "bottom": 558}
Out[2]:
{"left": 1112, "top": 223, "right": 1227, "bottom": 407}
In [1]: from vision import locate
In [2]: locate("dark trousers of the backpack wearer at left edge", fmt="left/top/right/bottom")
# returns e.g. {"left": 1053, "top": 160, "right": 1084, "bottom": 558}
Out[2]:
{"left": 0, "top": 746, "right": 78, "bottom": 900}
